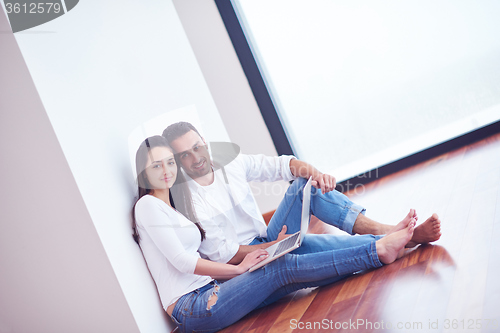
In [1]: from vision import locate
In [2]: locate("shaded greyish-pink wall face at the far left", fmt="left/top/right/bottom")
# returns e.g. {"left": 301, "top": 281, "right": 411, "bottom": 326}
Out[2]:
{"left": 0, "top": 10, "right": 142, "bottom": 333}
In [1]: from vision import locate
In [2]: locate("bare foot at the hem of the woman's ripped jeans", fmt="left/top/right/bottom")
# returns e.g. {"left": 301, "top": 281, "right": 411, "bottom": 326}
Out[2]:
{"left": 375, "top": 218, "right": 416, "bottom": 264}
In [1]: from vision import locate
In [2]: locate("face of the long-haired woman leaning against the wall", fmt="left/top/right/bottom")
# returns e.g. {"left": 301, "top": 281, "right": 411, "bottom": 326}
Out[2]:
{"left": 146, "top": 147, "right": 177, "bottom": 190}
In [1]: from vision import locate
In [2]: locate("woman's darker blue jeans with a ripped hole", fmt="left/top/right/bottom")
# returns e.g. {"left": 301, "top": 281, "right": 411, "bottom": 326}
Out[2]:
{"left": 172, "top": 239, "right": 382, "bottom": 332}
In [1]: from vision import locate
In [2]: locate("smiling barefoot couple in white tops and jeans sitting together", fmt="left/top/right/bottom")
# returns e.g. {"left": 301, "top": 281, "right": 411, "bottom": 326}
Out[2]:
{"left": 133, "top": 122, "right": 441, "bottom": 332}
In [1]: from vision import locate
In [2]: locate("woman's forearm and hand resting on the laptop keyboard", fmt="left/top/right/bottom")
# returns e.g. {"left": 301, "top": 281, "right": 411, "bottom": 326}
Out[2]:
{"left": 194, "top": 249, "right": 269, "bottom": 280}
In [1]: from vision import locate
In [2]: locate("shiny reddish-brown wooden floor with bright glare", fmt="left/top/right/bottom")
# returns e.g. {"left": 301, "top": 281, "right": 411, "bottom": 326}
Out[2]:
{"left": 221, "top": 134, "right": 500, "bottom": 333}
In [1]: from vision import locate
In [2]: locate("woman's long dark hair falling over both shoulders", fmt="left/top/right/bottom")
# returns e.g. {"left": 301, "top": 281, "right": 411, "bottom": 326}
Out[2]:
{"left": 132, "top": 135, "right": 205, "bottom": 244}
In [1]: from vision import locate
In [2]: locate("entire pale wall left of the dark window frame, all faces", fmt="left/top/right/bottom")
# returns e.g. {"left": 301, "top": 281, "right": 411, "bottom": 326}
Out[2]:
{"left": 0, "top": 0, "right": 292, "bottom": 333}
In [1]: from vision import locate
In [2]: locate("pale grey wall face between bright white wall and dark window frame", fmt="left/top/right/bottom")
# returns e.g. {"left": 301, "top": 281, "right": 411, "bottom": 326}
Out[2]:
{"left": 173, "top": 0, "right": 288, "bottom": 213}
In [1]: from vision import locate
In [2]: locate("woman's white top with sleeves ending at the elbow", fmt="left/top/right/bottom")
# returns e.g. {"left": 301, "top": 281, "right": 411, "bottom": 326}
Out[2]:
{"left": 135, "top": 195, "right": 213, "bottom": 310}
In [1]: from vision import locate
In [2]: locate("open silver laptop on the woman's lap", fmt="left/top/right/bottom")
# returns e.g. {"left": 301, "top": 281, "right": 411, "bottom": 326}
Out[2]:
{"left": 249, "top": 177, "right": 312, "bottom": 272}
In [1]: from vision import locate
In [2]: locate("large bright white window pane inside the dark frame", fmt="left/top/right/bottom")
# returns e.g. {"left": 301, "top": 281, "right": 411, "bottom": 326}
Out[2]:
{"left": 221, "top": 0, "right": 500, "bottom": 180}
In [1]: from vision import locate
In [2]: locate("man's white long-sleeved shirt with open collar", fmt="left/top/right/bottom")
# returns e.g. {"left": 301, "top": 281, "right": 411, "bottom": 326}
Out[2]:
{"left": 186, "top": 154, "right": 297, "bottom": 263}
